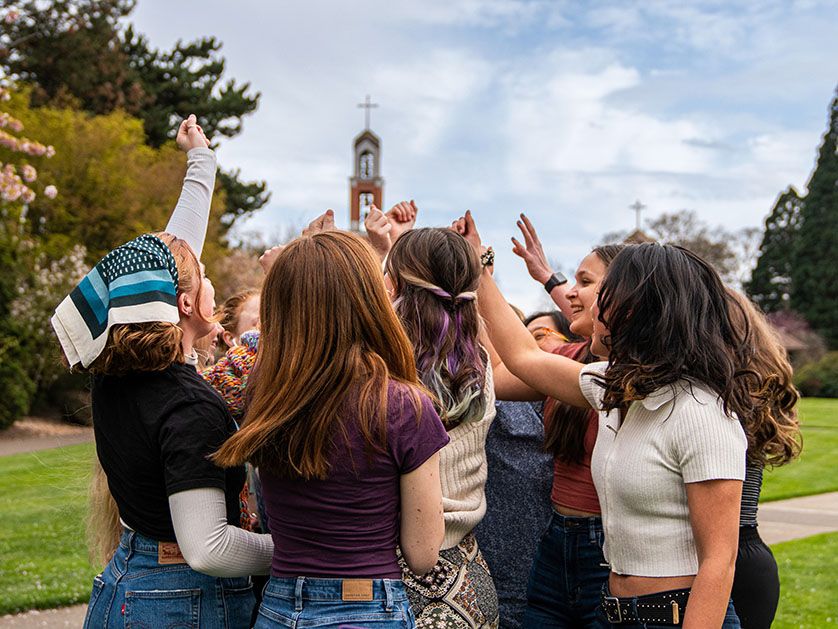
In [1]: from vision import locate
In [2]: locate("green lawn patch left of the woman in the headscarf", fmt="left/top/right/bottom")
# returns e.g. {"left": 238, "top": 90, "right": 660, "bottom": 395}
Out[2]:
{"left": 0, "top": 444, "right": 97, "bottom": 614}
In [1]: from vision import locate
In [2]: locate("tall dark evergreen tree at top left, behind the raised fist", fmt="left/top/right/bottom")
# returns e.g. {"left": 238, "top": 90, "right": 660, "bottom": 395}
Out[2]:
{"left": 0, "top": 0, "right": 269, "bottom": 229}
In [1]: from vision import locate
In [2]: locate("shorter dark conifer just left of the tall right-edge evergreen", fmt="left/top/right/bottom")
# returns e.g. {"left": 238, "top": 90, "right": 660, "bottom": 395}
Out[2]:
{"left": 745, "top": 186, "right": 803, "bottom": 312}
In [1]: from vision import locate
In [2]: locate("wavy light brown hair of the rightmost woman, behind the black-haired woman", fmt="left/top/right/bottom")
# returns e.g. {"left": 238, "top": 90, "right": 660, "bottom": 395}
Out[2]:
{"left": 728, "top": 289, "right": 802, "bottom": 465}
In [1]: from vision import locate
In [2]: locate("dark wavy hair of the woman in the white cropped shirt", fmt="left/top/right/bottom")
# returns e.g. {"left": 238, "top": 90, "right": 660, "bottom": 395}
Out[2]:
{"left": 598, "top": 243, "right": 759, "bottom": 417}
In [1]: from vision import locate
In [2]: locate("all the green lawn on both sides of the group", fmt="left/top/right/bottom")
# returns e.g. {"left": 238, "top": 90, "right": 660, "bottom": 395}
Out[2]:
{"left": 0, "top": 399, "right": 838, "bottom": 612}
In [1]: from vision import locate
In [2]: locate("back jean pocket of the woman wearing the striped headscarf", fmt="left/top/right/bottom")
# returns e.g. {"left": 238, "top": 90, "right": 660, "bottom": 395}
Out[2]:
{"left": 124, "top": 589, "right": 201, "bottom": 629}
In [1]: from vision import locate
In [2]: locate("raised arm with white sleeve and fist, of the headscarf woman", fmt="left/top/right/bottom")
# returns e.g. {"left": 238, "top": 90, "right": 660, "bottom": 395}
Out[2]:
{"left": 166, "top": 114, "right": 216, "bottom": 258}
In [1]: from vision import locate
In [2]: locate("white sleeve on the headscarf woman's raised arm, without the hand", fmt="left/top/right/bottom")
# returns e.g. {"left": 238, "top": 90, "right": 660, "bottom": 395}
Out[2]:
{"left": 166, "top": 149, "right": 216, "bottom": 258}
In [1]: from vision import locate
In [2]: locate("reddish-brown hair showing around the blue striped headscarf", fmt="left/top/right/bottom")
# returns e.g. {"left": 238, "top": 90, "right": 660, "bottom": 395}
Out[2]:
{"left": 76, "top": 232, "right": 203, "bottom": 376}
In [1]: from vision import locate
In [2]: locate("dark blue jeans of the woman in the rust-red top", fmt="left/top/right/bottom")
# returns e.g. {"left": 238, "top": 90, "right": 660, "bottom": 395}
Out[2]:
{"left": 523, "top": 511, "right": 610, "bottom": 629}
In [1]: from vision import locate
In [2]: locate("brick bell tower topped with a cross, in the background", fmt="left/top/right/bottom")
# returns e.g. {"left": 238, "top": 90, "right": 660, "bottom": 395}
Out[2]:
{"left": 349, "top": 94, "right": 384, "bottom": 232}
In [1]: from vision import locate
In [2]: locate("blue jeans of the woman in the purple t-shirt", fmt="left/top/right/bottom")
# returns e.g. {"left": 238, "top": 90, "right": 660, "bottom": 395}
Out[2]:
{"left": 253, "top": 577, "right": 416, "bottom": 629}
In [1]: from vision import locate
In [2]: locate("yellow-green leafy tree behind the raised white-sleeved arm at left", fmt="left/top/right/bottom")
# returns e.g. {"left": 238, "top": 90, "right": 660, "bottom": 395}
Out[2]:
{"left": 2, "top": 84, "right": 226, "bottom": 270}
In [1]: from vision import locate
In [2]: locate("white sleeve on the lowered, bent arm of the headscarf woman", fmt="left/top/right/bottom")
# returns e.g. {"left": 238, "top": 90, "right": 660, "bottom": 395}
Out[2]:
{"left": 169, "top": 487, "right": 274, "bottom": 577}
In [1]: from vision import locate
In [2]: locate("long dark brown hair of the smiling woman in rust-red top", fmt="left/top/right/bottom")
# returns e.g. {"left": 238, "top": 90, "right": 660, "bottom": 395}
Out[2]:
{"left": 544, "top": 244, "right": 626, "bottom": 465}
